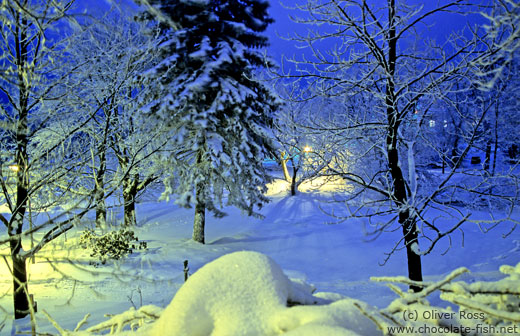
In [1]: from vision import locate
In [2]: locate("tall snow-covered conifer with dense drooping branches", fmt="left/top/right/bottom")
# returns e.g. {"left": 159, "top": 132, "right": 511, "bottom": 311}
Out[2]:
{"left": 137, "top": 0, "right": 279, "bottom": 243}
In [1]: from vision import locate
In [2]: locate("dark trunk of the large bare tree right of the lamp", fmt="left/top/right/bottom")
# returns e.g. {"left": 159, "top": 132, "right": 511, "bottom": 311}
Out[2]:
{"left": 385, "top": 0, "right": 422, "bottom": 292}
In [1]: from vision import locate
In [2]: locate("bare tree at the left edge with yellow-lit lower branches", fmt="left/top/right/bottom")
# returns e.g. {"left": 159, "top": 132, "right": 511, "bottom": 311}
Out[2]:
{"left": 0, "top": 1, "right": 164, "bottom": 318}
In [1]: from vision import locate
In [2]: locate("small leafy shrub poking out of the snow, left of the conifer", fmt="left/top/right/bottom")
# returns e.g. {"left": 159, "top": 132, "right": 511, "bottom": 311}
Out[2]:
{"left": 79, "top": 229, "right": 147, "bottom": 265}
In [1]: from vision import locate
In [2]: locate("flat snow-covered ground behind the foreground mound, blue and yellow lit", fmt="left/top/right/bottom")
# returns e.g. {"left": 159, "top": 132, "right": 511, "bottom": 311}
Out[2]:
{"left": 0, "top": 176, "right": 520, "bottom": 335}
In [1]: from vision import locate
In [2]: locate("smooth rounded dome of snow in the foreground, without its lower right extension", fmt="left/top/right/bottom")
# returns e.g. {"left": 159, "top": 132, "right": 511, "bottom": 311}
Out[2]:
{"left": 152, "top": 251, "right": 290, "bottom": 336}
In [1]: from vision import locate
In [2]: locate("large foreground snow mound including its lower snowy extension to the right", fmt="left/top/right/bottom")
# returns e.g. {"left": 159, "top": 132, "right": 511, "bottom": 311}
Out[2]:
{"left": 148, "top": 251, "right": 380, "bottom": 336}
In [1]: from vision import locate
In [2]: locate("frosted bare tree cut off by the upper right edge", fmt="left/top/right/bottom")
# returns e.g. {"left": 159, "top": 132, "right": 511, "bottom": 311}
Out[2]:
{"left": 472, "top": 0, "right": 520, "bottom": 169}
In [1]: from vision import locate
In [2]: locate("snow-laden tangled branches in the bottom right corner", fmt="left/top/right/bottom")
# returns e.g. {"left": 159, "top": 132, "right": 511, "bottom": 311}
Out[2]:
{"left": 371, "top": 263, "right": 520, "bottom": 335}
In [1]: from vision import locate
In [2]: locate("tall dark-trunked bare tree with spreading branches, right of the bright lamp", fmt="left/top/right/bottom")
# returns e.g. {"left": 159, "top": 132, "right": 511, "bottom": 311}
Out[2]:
{"left": 283, "top": 0, "right": 516, "bottom": 290}
